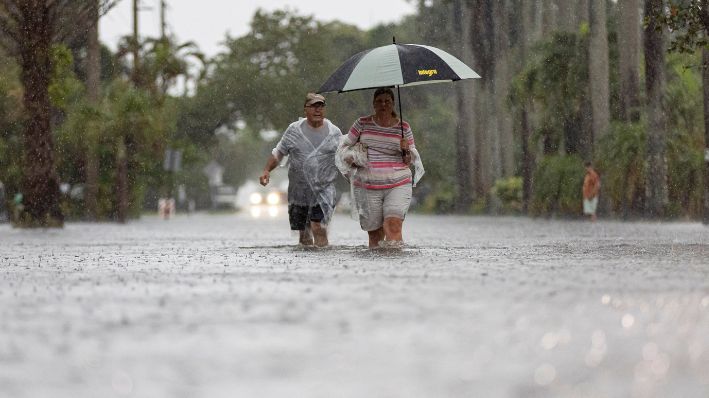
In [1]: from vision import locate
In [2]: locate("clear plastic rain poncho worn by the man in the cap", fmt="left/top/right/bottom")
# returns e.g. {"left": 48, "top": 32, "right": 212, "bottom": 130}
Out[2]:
{"left": 273, "top": 118, "right": 342, "bottom": 224}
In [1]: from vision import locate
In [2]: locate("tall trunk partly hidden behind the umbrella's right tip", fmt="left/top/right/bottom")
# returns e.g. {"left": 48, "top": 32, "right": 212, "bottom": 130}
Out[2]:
{"left": 451, "top": 0, "right": 474, "bottom": 213}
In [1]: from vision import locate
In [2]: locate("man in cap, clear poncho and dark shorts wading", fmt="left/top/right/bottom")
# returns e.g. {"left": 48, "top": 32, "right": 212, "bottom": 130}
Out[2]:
{"left": 259, "top": 93, "right": 342, "bottom": 247}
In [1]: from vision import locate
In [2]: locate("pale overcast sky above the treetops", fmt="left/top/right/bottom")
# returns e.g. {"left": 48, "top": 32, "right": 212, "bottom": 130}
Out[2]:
{"left": 99, "top": 0, "right": 415, "bottom": 56}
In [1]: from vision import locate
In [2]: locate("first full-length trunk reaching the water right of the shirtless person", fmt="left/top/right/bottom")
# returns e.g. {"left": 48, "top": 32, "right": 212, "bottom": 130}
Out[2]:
{"left": 644, "top": 0, "right": 668, "bottom": 217}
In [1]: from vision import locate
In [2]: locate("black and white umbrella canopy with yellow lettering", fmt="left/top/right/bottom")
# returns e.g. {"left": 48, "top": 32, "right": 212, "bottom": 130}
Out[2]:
{"left": 318, "top": 43, "right": 480, "bottom": 93}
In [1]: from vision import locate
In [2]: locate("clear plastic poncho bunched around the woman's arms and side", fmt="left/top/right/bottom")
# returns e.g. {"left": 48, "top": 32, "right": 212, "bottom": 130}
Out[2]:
{"left": 335, "top": 135, "right": 426, "bottom": 220}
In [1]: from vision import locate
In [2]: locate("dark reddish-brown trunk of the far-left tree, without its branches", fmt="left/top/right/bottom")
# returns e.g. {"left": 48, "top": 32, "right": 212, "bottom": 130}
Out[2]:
{"left": 18, "top": 2, "right": 64, "bottom": 227}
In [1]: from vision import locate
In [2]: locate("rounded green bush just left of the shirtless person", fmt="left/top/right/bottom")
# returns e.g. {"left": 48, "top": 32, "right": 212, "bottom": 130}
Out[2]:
{"left": 529, "top": 155, "right": 584, "bottom": 216}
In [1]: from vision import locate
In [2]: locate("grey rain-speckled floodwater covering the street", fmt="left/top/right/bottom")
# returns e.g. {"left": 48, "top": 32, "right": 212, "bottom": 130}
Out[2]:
{"left": 0, "top": 213, "right": 709, "bottom": 398}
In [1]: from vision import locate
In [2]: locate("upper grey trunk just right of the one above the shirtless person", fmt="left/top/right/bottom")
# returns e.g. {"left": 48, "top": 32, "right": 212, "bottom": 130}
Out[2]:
{"left": 618, "top": 0, "right": 640, "bottom": 122}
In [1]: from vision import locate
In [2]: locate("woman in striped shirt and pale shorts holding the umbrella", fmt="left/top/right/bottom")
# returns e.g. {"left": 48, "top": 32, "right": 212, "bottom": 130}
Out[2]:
{"left": 338, "top": 88, "right": 423, "bottom": 248}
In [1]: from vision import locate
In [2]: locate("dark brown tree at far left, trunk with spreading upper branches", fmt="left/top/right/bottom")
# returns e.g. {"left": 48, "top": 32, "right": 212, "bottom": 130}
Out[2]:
{"left": 0, "top": 0, "right": 113, "bottom": 227}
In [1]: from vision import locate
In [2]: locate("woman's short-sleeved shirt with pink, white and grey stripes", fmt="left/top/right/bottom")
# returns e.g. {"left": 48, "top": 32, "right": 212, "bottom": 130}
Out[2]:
{"left": 347, "top": 116, "right": 414, "bottom": 189}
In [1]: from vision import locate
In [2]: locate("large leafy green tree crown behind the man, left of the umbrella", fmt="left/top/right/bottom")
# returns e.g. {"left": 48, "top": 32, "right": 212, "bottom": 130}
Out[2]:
{"left": 198, "top": 11, "right": 364, "bottom": 133}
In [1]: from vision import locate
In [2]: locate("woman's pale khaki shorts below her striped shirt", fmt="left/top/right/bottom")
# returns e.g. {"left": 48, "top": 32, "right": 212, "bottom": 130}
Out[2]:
{"left": 355, "top": 184, "right": 411, "bottom": 231}
